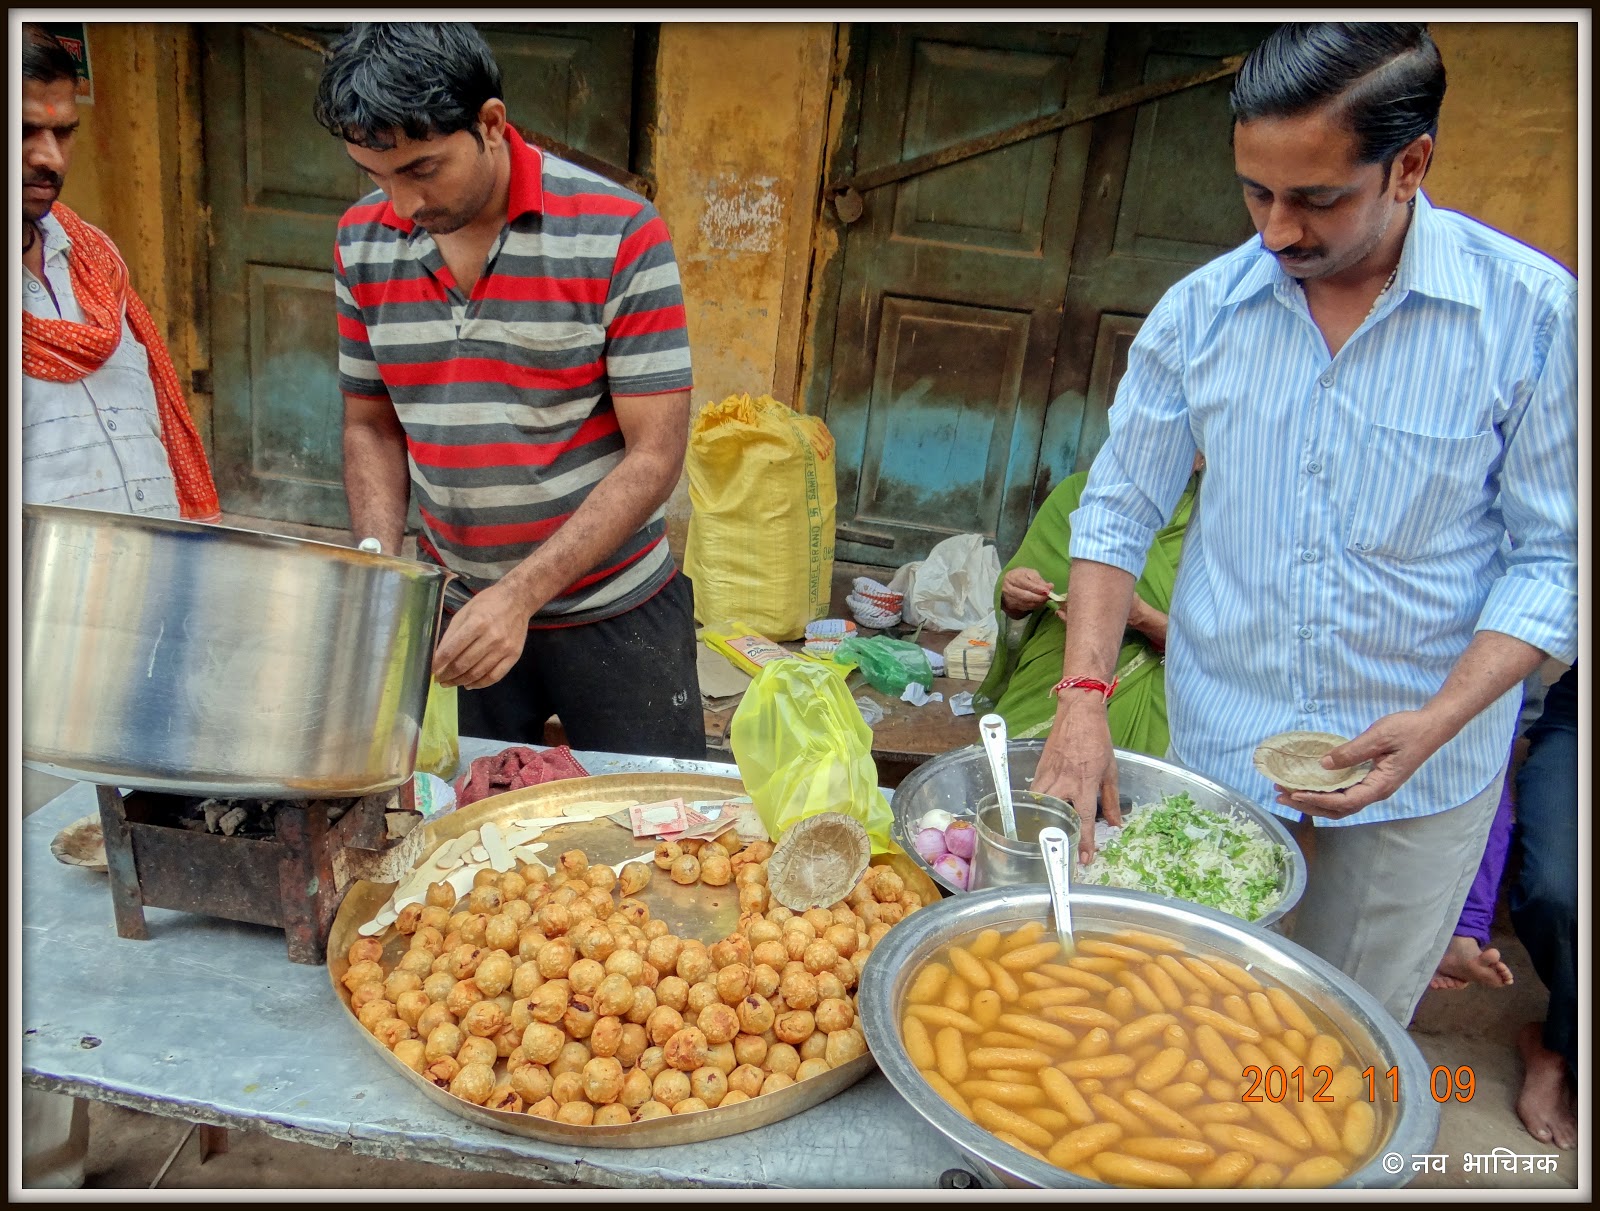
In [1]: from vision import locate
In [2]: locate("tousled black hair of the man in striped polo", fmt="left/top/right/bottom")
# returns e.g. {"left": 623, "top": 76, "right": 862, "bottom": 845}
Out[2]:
{"left": 314, "top": 21, "right": 501, "bottom": 152}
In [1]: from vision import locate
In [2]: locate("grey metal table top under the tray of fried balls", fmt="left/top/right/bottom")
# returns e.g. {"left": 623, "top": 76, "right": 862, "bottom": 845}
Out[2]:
{"left": 21, "top": 739, "right": 994, "bottom": 1189}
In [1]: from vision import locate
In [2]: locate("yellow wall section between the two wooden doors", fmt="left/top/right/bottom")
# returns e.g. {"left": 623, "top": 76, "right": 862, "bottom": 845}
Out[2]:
{"left": 653, "top": 22, "right": 834, "bottom": 555}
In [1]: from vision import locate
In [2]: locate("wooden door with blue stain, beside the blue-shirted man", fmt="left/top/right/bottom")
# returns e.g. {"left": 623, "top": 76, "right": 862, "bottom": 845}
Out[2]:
{"left": 811, "top": 22, "right": 1270, "bottom": 568}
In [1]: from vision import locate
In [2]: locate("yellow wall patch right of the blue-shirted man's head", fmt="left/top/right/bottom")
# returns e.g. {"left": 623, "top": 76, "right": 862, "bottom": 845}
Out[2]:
{"left": 1426, "top": 22, "right": 1578, "bottom": 272}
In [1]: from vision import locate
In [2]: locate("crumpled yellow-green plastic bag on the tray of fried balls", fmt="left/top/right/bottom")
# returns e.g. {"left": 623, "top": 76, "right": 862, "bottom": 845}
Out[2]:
{"left": 728, "top": 661, "right": 893, "bottom": 854}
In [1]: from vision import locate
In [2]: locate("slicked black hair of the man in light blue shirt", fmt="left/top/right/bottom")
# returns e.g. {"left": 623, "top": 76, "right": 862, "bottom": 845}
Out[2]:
{"left": 1227, "top": 21, "right": 1445, "bottom": 173}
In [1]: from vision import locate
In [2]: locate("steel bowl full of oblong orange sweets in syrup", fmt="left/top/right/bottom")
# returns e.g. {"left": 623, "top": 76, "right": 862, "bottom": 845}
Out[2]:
{"left": 859, "top": 886, "right": 1440, "bottom": 1189}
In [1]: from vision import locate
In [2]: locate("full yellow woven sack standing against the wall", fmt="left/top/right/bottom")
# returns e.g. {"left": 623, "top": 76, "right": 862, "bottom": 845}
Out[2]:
{"left": 683, "top": 395, "right": 837, "bottom": 643}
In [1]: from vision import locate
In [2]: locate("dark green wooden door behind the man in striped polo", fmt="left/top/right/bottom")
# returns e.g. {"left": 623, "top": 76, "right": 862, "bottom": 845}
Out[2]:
{"left": 203, "top": 24, "right": 634, "bottom": 528}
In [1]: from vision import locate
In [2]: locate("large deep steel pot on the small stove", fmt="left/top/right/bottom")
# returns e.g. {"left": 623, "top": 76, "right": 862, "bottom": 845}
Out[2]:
{"left": 22, "top": 506, "right": 448, "bottom": 798}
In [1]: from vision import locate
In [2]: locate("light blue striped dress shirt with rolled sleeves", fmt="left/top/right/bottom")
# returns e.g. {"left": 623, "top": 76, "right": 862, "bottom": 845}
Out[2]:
{"left": 1070, "top": 195, "right": 1578, "bottom": 825}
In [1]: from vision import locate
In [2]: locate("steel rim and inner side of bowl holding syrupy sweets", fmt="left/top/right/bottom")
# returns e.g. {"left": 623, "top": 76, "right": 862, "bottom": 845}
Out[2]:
{"left": 858, "top": 886, "right": 1440, "bottom": 1190}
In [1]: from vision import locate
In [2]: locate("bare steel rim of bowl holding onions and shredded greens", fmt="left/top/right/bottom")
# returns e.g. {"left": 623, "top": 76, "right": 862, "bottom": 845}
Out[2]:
{"left": 891, "top": 741, "right": 1306, "bottom": 928}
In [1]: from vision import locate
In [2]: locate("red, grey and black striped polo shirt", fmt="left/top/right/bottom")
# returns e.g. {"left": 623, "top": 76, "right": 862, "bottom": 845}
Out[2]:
{"left": 333, "top": 131, "right": 691, "bottom": 625}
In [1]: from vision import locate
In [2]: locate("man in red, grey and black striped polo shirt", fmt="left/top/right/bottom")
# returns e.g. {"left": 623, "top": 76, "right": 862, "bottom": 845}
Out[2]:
{"left": 315, "top": 22, "right": 706, "bottom": 758}
